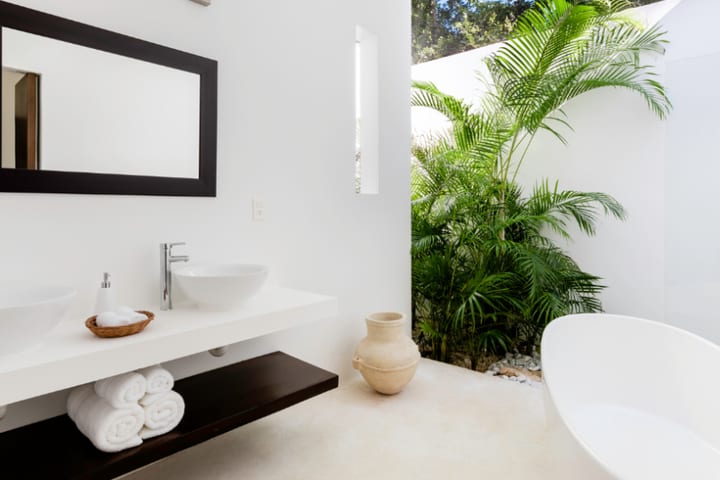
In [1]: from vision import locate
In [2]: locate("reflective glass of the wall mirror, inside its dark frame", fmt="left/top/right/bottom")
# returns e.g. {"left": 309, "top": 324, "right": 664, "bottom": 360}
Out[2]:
{"left": 2, "top": 27, "right": 200, "bottom": 179}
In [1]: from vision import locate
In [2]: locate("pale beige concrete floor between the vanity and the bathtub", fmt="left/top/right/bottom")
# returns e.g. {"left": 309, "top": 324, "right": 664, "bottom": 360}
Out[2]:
{"left": 123, "top": 359, "right": 587, "bottom": 480}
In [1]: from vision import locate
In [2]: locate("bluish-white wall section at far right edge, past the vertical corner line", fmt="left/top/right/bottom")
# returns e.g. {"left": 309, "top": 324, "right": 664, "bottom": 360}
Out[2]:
{"left": 663, "top": 0, "right": 720, "bottom": 343}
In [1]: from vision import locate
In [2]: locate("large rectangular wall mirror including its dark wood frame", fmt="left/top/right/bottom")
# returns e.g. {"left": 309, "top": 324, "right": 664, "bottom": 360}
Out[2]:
{"left": 0, "top": 2, "right": 217, "bottom": 196}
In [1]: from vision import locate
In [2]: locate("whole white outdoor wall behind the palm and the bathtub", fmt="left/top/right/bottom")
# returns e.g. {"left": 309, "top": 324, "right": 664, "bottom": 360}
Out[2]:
{"left": 413, "top": 0, "right": 720, "bottom": 342}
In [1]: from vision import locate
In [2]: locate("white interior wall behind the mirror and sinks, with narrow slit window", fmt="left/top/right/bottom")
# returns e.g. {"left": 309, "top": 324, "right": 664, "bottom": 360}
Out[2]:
{"left": 0, "top": 0, "right": 410, "bottom": 429}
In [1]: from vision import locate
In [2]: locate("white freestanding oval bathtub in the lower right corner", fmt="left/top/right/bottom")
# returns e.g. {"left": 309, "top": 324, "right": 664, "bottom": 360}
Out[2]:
{"left": 542, "top": 314, "right": 720, "bottom": 480}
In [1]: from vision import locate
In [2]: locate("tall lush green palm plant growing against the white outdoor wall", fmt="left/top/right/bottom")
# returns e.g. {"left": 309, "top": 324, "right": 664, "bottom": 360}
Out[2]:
{"left": 412, "top": 0, "right": 670, "bottom": 360}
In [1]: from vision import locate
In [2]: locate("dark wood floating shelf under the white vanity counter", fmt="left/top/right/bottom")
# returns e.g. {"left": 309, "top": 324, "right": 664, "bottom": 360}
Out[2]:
{"left": 0, "top": 352, "right": 338, "bottom": 480}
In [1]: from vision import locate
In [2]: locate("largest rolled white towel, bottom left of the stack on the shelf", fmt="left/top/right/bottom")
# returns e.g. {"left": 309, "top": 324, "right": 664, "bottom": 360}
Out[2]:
{"left": 68, "top": 385, "right": 145, "bottom": 452}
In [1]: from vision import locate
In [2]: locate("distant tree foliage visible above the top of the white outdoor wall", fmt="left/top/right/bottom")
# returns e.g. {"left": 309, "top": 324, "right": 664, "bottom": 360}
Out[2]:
{"left": 412, "top": 0, "right": 659, "bottom": 63}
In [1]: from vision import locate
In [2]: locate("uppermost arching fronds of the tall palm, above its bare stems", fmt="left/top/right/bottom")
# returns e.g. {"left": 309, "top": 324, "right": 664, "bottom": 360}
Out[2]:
{"left": 486, "top": 0, "right": 671, "bottom": 140}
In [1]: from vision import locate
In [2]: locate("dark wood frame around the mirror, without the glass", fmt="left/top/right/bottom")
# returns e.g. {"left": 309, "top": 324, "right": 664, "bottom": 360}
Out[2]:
{"left": 0, "top": 1, "right": 217, "bottom": 197}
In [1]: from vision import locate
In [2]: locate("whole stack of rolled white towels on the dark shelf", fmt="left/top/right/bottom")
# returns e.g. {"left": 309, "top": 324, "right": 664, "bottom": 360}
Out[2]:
{"left": 67, "top": 365, "right": 185, "bottom": 452}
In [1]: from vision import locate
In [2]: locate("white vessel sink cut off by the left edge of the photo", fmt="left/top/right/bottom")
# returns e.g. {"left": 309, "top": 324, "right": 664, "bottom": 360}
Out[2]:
{"left": 0, "top": 286, "right": 75, "bottom": 355}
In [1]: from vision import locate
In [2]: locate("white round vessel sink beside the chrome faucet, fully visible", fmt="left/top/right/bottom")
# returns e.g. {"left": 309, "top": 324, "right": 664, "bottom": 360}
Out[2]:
{"left": 174, "top": 263, "right": 269, "bottom": 310}
